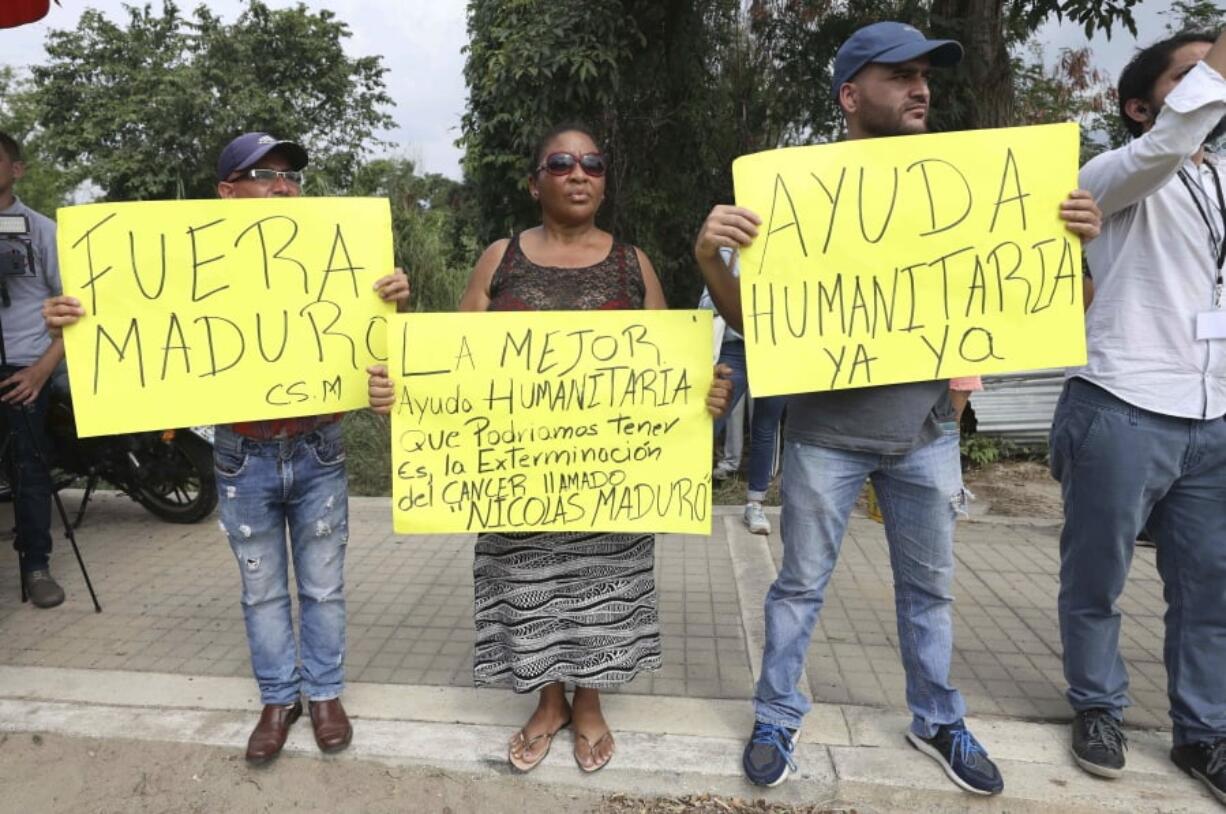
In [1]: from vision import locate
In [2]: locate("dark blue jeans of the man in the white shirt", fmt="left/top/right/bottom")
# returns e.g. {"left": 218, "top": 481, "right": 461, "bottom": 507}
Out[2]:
{"left": 1051, "top": 379, "right": 1226, "bottom": 745}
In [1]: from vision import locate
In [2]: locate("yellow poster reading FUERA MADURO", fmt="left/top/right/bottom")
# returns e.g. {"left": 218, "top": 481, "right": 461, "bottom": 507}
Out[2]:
{"left": 58, "top": 197, "right": 395, "bottom": 435}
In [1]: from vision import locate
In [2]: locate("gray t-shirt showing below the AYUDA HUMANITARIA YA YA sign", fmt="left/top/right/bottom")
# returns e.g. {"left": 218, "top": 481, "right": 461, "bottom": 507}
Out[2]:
{"left": 785, "top": 379, "right": 954, "bottom": 455}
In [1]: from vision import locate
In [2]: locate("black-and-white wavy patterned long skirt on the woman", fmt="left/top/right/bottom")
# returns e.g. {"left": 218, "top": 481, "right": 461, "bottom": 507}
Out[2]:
{"left": 472, "top": 533, "right": 661, "bottom": 693}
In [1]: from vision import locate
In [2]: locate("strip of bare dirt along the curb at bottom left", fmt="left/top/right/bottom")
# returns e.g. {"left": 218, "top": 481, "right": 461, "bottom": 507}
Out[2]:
{"left": 0, "top": 733, "right": 856, "bottom": 814}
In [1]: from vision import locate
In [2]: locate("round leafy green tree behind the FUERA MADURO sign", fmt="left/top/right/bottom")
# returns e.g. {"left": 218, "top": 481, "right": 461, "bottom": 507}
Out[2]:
{"left": 29, "top": 0, "right": 391, "bottom": 200}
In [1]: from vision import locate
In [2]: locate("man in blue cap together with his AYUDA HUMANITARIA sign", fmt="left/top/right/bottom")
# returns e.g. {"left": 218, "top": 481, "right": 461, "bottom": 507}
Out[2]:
{"left": 694, "top": 21, "right": 1101, "bottom": 794}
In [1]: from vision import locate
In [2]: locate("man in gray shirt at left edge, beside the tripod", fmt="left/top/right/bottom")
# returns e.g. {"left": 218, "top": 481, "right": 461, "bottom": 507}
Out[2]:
{"left": 0, "top": 132, "right": 64, "bottom": 608}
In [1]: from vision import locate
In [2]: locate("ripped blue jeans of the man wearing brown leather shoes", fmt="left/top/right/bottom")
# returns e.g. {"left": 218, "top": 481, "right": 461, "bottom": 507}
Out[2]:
{"left": 213, "top": 423, "right": 349, "bottom": 704}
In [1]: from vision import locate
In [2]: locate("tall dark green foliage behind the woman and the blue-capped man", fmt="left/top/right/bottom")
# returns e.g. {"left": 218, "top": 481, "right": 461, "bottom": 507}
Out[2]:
{"left": 461, "top": 0, "right": 1137, "bottom": 305}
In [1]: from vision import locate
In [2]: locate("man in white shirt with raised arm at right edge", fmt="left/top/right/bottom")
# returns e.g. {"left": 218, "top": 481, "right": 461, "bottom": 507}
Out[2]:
{"left": 1051, "top": 34, "right": 1226, "bottom": 803}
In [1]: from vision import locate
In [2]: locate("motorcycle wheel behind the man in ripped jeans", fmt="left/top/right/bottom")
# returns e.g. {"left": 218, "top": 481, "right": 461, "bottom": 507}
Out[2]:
{"left": 132, "top": 432, "right": 217, "bottom": 523}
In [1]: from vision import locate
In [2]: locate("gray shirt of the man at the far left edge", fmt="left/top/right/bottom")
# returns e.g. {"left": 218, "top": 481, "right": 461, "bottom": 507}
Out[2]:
{"left": 0, "top": 200, "right": 63, "bottom": 368}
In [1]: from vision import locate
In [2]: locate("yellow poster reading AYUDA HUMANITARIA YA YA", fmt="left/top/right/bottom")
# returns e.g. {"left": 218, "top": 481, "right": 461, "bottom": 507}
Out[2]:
{"left": 732, "top": 124, "right": 1085, "bottom": 396}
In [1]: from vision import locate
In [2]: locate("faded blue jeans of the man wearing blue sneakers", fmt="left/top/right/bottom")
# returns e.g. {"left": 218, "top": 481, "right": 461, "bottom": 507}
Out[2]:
{"left": 754, "top": 431, "right": 966, "bottom": 738}
